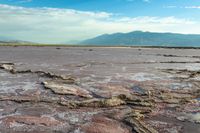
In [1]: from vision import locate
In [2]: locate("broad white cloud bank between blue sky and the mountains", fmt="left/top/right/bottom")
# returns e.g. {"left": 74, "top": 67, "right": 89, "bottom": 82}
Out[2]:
{"left": 0, "top": 5, "right": 200, "bottom": 43}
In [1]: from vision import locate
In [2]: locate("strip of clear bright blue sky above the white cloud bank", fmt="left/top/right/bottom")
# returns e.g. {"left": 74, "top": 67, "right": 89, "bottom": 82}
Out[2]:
{"left": 0, "top": 0, "right": 200, "bottom": 18}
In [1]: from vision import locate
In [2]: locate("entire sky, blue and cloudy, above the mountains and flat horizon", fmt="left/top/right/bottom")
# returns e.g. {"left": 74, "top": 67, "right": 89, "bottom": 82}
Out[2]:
{"left": 0, "top": 0, "right": 200, "bottom": 43}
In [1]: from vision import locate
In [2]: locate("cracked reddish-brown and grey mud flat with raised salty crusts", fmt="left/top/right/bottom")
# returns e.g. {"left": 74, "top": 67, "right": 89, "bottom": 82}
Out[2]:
{"left": 0, "top": 46, "right": 200, "bottom": 133}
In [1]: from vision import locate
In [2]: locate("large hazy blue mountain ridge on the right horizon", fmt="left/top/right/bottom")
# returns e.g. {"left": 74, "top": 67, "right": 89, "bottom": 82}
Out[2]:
{"left": 81, "top": 31, "right": 200, "bottom": 47}
